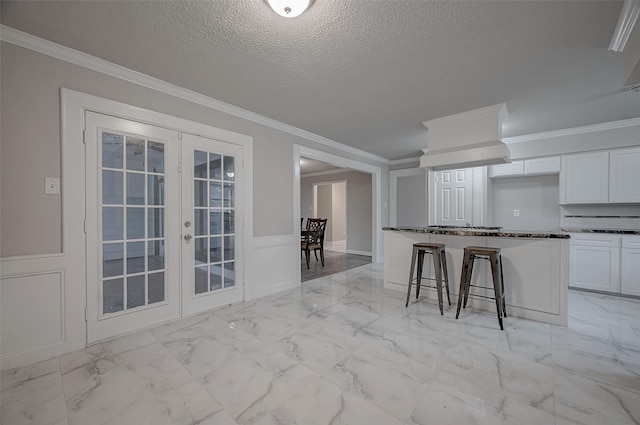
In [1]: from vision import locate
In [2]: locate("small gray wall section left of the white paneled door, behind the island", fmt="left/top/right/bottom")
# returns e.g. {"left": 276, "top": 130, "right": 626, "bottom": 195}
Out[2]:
{"left": 396, "top": 174, "right": 427, "bottom": 227}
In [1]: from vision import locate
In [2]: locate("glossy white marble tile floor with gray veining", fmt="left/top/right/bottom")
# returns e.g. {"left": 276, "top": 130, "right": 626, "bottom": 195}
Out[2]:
{"left": 0, "top": 264, "right": 640, "bottom": 425}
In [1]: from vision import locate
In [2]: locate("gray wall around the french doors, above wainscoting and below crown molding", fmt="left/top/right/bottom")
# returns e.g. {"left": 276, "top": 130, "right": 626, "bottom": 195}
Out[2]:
{"left": 0, "top": 42, "right": 389, "bottom": 257}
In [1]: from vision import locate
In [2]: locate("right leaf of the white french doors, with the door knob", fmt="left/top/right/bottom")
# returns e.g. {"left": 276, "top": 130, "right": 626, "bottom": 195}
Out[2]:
{"left": 182, "top": 134, "right": 244, "bottom": 314}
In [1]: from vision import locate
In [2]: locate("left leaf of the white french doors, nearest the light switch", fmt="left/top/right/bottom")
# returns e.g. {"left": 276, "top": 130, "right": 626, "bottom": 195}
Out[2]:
{"left": 85, "top": 112, "right": 180, "bottom": 343}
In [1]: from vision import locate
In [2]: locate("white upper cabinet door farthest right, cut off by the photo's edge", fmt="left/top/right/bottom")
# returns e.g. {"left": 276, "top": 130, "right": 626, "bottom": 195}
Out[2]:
{"left": 609, "top": 147, "right": 640, "bottom": 203}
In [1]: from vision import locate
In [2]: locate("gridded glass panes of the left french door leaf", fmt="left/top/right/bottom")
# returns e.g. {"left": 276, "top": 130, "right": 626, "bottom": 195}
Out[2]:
{"left": 98, "top": 132, "right": 167, "bottom": 317}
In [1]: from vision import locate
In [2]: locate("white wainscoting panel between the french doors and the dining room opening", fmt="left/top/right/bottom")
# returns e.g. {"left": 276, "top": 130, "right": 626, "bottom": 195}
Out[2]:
{"left": 245, "top": 235, "right": 300, "bottom": 301}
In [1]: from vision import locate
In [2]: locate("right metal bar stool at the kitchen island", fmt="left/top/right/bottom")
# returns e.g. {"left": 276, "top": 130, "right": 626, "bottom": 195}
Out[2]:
{"left": 456, "top": 246, "right": 507, "bottom": 330}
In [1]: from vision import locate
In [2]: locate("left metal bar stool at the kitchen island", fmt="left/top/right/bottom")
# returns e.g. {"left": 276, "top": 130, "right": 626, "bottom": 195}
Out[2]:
{"left": 405, "top": 242, "right": 451, "bottom": 314}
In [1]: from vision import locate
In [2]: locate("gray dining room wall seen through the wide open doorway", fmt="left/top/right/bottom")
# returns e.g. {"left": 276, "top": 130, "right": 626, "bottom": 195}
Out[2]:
{"left": 300, "top": 171, "right": 372, "bottom": 252}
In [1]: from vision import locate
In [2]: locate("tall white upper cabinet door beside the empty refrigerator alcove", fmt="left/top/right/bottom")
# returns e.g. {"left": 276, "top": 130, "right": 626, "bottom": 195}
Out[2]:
{"left": 561, "top": 152, "right": 609, "bottom": 204}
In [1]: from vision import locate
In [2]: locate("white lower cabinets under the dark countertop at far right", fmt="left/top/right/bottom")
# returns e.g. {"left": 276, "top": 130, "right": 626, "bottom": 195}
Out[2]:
{"left": 569, "top": 233, "right": 640, "bottom": 296}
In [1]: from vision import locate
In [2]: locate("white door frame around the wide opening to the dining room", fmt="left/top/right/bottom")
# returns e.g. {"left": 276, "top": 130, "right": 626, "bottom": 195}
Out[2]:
{"left": 292, "top": 145, "right": 383, "bottom": 274}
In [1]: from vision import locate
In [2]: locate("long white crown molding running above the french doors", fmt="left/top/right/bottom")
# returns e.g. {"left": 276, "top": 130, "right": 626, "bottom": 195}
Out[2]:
{"left": 0, "top": 25, "right": 389, "bottom": 165}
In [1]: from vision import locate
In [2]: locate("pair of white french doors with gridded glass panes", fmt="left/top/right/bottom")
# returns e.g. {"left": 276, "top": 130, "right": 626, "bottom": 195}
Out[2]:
{"left": 85, "top": 112, "right": 243, "bottom": 343}
